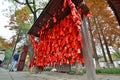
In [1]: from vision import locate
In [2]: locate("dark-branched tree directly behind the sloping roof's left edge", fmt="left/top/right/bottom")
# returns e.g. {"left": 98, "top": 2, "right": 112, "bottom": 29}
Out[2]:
{"left": 11, "top": 0, "right": 48, "bottom": 59}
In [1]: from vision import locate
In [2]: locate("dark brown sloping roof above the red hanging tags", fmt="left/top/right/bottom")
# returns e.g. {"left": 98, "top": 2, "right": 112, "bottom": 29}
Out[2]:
{"left": 28, "top": 0, "right": 89, "bottom": 36}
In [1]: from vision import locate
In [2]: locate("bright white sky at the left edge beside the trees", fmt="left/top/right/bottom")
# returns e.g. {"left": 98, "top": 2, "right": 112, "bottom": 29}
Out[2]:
{"left": 0, "top": 0, "right": 15, "bottom": 40}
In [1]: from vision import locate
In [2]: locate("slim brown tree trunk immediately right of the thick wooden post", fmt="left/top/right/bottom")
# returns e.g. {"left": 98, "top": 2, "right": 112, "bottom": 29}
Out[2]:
{"left": 88, "top": 18, "right": 100, "bottom": 68}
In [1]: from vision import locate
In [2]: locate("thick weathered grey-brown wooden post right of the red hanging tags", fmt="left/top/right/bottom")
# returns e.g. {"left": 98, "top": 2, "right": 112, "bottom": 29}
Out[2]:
{"left": 81, "top": 16, "right": 96, "bottom": 80}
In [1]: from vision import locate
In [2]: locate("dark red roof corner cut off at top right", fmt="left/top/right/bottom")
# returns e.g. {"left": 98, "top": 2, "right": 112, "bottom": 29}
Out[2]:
{"left": 107, "top": 0, "right": 120, "bottom": 25}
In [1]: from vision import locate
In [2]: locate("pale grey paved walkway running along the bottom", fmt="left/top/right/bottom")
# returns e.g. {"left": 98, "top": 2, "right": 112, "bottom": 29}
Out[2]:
{"left": 0, "top": 68, "right": 120, "bottom": 80}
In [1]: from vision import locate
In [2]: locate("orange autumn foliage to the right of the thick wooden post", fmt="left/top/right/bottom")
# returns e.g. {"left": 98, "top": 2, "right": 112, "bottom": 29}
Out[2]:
{"left": 85, "top": 0, "right": 119, "bottom": 46}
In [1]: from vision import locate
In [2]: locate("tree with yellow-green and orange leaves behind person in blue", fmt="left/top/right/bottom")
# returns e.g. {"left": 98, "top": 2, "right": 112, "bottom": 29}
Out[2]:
{"left": 7, "top": 6, "right": 30, "bottom": 64}
